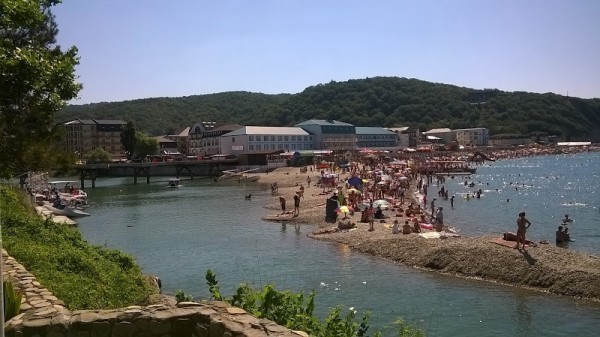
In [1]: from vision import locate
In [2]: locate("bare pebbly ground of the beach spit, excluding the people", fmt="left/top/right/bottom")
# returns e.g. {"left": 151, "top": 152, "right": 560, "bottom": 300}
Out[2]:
{"left": 259, "top": 167, "right": 600, "bottom": 301}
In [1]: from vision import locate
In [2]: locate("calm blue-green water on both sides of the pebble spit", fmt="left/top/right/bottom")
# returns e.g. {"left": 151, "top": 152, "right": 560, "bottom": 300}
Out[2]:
{"left": 79, "top": 154, "right": 600, "bottom": 336}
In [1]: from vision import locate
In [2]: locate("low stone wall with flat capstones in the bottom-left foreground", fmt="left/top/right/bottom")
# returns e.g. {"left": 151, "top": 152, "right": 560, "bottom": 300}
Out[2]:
{"left": 2, "top": 251, "right": 308, "bottom": 337}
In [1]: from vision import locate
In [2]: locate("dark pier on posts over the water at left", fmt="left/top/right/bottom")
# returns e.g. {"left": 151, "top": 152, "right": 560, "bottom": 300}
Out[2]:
{"left": 74, "top": 159, "right": 238, "bottom": 189}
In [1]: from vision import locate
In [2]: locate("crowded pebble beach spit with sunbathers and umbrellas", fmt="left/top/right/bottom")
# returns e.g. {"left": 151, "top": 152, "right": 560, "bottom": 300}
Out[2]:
{"left": 259, "top": 148, "right": 600, "bottom": 301}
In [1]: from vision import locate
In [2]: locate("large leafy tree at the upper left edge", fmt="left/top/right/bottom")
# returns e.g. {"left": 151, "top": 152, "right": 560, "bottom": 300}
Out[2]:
{"left": 0, "top": 0, "right": 81, "bottom": 177}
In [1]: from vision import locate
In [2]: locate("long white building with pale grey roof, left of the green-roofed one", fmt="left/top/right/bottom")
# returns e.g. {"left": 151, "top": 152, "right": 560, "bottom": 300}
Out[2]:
{"left": 220, "top": 126, "right": 315, "bottom": 154}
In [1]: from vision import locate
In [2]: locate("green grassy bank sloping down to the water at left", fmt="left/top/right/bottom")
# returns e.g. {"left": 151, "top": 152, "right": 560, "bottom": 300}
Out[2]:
{"left": 0, "top": 186, "right": 156, "bottom": 310}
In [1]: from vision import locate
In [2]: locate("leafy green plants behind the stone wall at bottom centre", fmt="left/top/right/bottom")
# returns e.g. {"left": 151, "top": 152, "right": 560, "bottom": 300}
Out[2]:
{"left": 190, "top": 270, "right": 426, "bottom": 337}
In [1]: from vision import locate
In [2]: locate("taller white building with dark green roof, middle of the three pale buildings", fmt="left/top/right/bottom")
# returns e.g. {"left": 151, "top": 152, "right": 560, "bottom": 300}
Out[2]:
{"left": 296, "top": 119, "right": 356, "bottom": 151}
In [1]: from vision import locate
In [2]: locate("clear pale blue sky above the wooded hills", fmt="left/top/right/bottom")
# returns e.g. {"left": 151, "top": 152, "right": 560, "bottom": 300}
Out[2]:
{"left": 54, "top": 0, "right": 600, "bottom": 104}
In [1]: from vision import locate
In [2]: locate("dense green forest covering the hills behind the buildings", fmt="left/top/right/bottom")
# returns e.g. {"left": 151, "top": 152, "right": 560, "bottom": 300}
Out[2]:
{"left": 56, "top": 77, "right": 600, "bottom": 141}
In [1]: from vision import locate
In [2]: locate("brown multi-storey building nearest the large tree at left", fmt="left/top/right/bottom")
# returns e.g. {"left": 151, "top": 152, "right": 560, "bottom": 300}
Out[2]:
{"left": 61, "top": 119, "right": 127, "bottom": 157}
